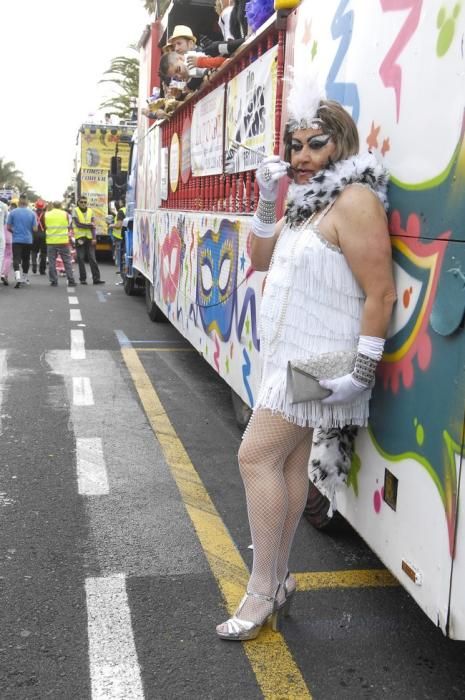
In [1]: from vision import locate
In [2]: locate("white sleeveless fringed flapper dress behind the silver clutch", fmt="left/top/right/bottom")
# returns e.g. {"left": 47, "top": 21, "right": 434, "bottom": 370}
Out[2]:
{"left": 254, "top": 207, "right": 370, "bottom": 429}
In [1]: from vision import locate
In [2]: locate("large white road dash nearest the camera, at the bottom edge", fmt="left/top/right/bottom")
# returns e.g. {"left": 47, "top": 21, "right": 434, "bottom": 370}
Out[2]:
{"left": 86, "top": 574, "right": 144, "bottom": 700}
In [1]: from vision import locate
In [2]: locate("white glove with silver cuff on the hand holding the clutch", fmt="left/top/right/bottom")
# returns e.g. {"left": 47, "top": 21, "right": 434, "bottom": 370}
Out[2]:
{"left": 320, "top": 335, "right": 385, "bottom": 404}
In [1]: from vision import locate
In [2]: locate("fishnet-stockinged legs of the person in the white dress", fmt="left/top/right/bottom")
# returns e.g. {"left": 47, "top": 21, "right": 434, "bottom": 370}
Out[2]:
{"left": 226, "top": 409, "right": 312, "bottom": 622}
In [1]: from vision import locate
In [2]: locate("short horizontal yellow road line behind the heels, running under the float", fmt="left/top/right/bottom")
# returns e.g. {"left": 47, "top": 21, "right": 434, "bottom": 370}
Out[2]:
{"left": 294, "top": 569, "right": 400, "bottom": 591}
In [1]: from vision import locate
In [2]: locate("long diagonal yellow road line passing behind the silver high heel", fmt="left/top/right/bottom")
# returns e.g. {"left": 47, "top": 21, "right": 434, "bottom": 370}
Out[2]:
{"left": 121, "top": 347, "right": 311, "bottom": 700}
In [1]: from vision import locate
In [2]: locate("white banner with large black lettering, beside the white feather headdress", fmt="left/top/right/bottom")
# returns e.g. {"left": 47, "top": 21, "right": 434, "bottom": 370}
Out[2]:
{"left": 224, "top": 46, "right": 278, "bottom": 173}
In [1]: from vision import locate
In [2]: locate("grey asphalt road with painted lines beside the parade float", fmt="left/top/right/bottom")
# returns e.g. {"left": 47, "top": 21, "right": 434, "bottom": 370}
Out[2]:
{"left": 0, "top": 265, "right": 465, "bottom": 700}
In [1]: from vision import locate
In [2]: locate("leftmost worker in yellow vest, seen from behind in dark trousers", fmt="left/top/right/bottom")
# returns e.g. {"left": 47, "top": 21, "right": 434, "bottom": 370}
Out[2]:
{"left": 44, "top": 202, "right": 76, "bottom": 287}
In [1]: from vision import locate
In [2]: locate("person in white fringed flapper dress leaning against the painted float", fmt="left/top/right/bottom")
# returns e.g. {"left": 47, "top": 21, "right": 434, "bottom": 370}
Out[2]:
{"left": 216, "top": 75, "right": 396, "bottom": 641}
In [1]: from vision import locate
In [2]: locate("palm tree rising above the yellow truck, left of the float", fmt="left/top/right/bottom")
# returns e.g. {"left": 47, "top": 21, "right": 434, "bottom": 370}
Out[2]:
{"left": 99, "top": 44, "right": 139, "bottom": 119}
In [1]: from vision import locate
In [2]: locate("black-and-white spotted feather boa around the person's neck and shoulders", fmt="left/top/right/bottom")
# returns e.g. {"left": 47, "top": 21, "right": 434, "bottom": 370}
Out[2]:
{"left": 286, "top": 152, "right": 389, "bottom": 224}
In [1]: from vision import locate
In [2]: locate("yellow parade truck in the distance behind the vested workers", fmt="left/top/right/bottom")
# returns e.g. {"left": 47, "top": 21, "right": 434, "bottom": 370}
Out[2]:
{"left": 75, "top": 122, "right": 134, "bottom": 256}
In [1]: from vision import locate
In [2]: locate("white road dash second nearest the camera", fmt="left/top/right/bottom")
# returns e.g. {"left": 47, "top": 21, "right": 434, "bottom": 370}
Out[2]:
{"left": 76, "top": 438, "right": 110, "bottom": 496}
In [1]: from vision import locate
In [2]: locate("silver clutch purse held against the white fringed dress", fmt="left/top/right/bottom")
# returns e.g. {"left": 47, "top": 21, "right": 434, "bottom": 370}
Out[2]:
{"left": 286, "top": 350, "right": 357, "bottom": 404}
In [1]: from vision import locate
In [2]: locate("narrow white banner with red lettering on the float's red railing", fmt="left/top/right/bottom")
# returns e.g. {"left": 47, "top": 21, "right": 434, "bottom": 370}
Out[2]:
{"left": 191, "top": 85, "right": 224, "bottom": 175}
